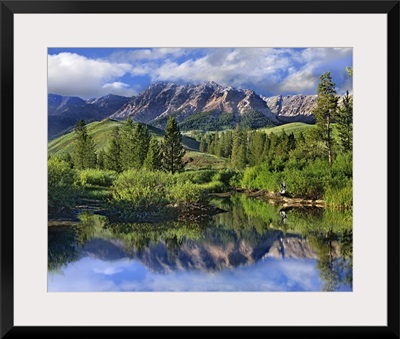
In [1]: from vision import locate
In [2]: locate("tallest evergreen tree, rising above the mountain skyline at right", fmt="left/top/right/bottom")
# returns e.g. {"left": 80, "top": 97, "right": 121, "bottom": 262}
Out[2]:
{"left": 313, "top": 72, "right": 338, "bottom": 165}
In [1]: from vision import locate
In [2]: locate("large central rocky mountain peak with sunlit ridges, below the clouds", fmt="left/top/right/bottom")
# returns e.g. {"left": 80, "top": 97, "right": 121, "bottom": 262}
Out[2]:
{"left": 111, "top": 81, "right": 277, "bottom": 127}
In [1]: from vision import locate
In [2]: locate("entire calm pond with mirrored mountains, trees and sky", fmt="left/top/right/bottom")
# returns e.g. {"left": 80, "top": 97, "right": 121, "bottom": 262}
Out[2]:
{"left": 48, "top": 194, "right": 353, "bottom": 292}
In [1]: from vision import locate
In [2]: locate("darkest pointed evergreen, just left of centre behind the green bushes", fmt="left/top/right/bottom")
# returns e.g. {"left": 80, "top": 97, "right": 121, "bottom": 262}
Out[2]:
{"left": 162, "top": 116, "right": 185, "bottom": 173}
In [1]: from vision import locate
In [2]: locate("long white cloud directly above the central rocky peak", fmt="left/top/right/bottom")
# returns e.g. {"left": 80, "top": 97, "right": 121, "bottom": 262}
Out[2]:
{"left": 140, "top": 48, "right": 290, "bottom": 93}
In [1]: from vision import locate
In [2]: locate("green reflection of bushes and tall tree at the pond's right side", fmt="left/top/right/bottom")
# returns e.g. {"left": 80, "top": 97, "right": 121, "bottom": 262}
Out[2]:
{"left": 225, "top": 195, "right": 353, "bottom": 291}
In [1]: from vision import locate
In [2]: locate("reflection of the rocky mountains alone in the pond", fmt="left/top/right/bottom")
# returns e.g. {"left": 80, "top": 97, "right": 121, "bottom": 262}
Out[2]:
{"left": 80, "top": 231, "right": 324, "bottom": 273}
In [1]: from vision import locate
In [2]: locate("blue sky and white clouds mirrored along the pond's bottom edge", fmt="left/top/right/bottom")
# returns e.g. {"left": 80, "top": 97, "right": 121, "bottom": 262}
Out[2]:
{"left": 48, "top": 258, "right": 321, "bottom": 292}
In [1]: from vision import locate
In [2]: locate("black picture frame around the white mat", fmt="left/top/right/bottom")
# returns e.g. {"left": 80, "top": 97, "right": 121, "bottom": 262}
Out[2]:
{"left": 0, "top": 1, "right": 400, "bottom": 338}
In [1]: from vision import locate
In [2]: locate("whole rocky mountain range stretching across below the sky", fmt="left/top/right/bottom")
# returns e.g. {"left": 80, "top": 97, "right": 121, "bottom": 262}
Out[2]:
{"left": 48, "top": 82, "right": 317, "bottom": 139}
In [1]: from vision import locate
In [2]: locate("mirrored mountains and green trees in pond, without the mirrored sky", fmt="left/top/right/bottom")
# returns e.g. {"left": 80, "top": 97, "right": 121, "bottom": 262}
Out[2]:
{"left": 48, "top": 195, "right": 353, "bottom": 291}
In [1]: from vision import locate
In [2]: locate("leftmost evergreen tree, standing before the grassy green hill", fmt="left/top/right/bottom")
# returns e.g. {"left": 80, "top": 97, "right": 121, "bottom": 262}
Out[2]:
{"left": 72, "top": 120, "right": 96, "bottom": 169}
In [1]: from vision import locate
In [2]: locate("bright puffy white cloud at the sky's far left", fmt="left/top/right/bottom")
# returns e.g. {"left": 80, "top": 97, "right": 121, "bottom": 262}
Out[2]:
{"left": 48, "top": 53, "right": 131, "bottom": 98}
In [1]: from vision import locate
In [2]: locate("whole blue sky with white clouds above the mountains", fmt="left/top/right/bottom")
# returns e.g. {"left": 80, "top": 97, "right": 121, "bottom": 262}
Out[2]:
{"left": 48, "top": 48, "right": 353, "bottom": 99}
